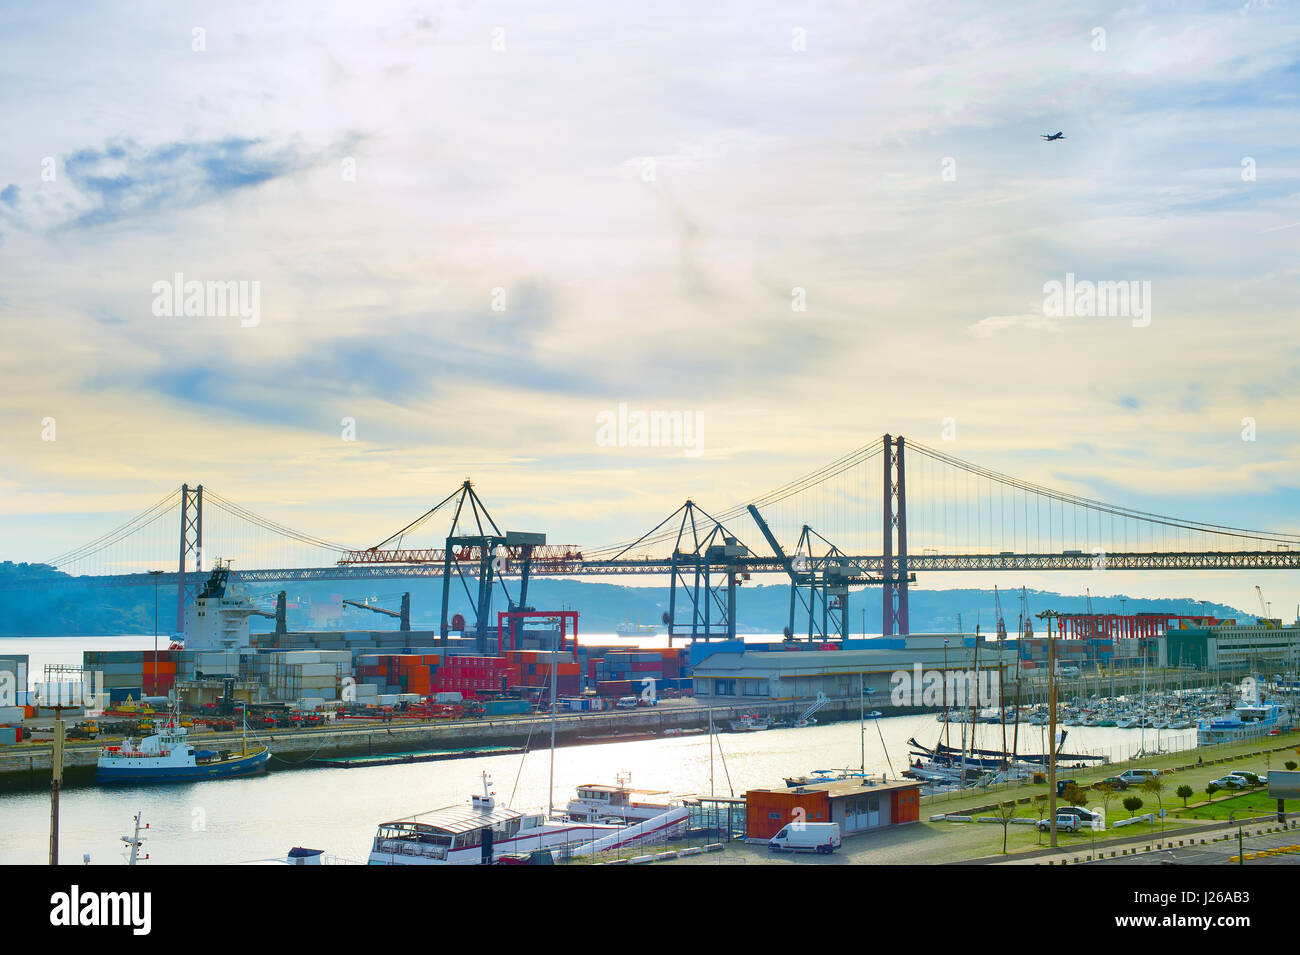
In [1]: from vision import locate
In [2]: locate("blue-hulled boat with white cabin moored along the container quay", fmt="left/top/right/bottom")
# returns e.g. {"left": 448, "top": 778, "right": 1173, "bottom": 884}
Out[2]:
{"left": 95, "top": 712, "right": 270, "bottom": 782}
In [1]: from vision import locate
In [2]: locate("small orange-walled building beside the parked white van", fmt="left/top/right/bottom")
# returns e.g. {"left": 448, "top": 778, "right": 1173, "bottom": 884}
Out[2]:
{"left": 745, "top": 778, "right": 920, "bottom": 841}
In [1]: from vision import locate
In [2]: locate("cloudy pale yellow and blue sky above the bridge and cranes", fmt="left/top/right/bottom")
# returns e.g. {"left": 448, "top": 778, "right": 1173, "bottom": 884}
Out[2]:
{"left": 0, "top": 0, "right": 1300, "bottom": 616}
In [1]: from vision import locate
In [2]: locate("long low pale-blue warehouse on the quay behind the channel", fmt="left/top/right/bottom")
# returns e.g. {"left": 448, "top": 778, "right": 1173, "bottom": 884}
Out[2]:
{"left": 693, "top": 634, "right": 1015, "bottom": 707}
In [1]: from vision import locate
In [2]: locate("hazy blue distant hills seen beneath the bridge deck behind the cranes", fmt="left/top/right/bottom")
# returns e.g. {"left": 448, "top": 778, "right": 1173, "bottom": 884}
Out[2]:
{"left": 0, "top": 561, "right": 1255, "bottom": 637}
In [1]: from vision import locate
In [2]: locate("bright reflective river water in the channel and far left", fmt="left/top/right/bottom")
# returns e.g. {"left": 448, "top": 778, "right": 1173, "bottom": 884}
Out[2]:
{"left": 0, "top": 634, "right": 1196, "bottom": 865}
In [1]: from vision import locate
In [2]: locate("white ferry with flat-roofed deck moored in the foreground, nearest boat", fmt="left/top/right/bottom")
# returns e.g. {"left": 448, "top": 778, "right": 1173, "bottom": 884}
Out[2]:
{"left": 368, "top": 773, "right": 627, "bottom": 865}
